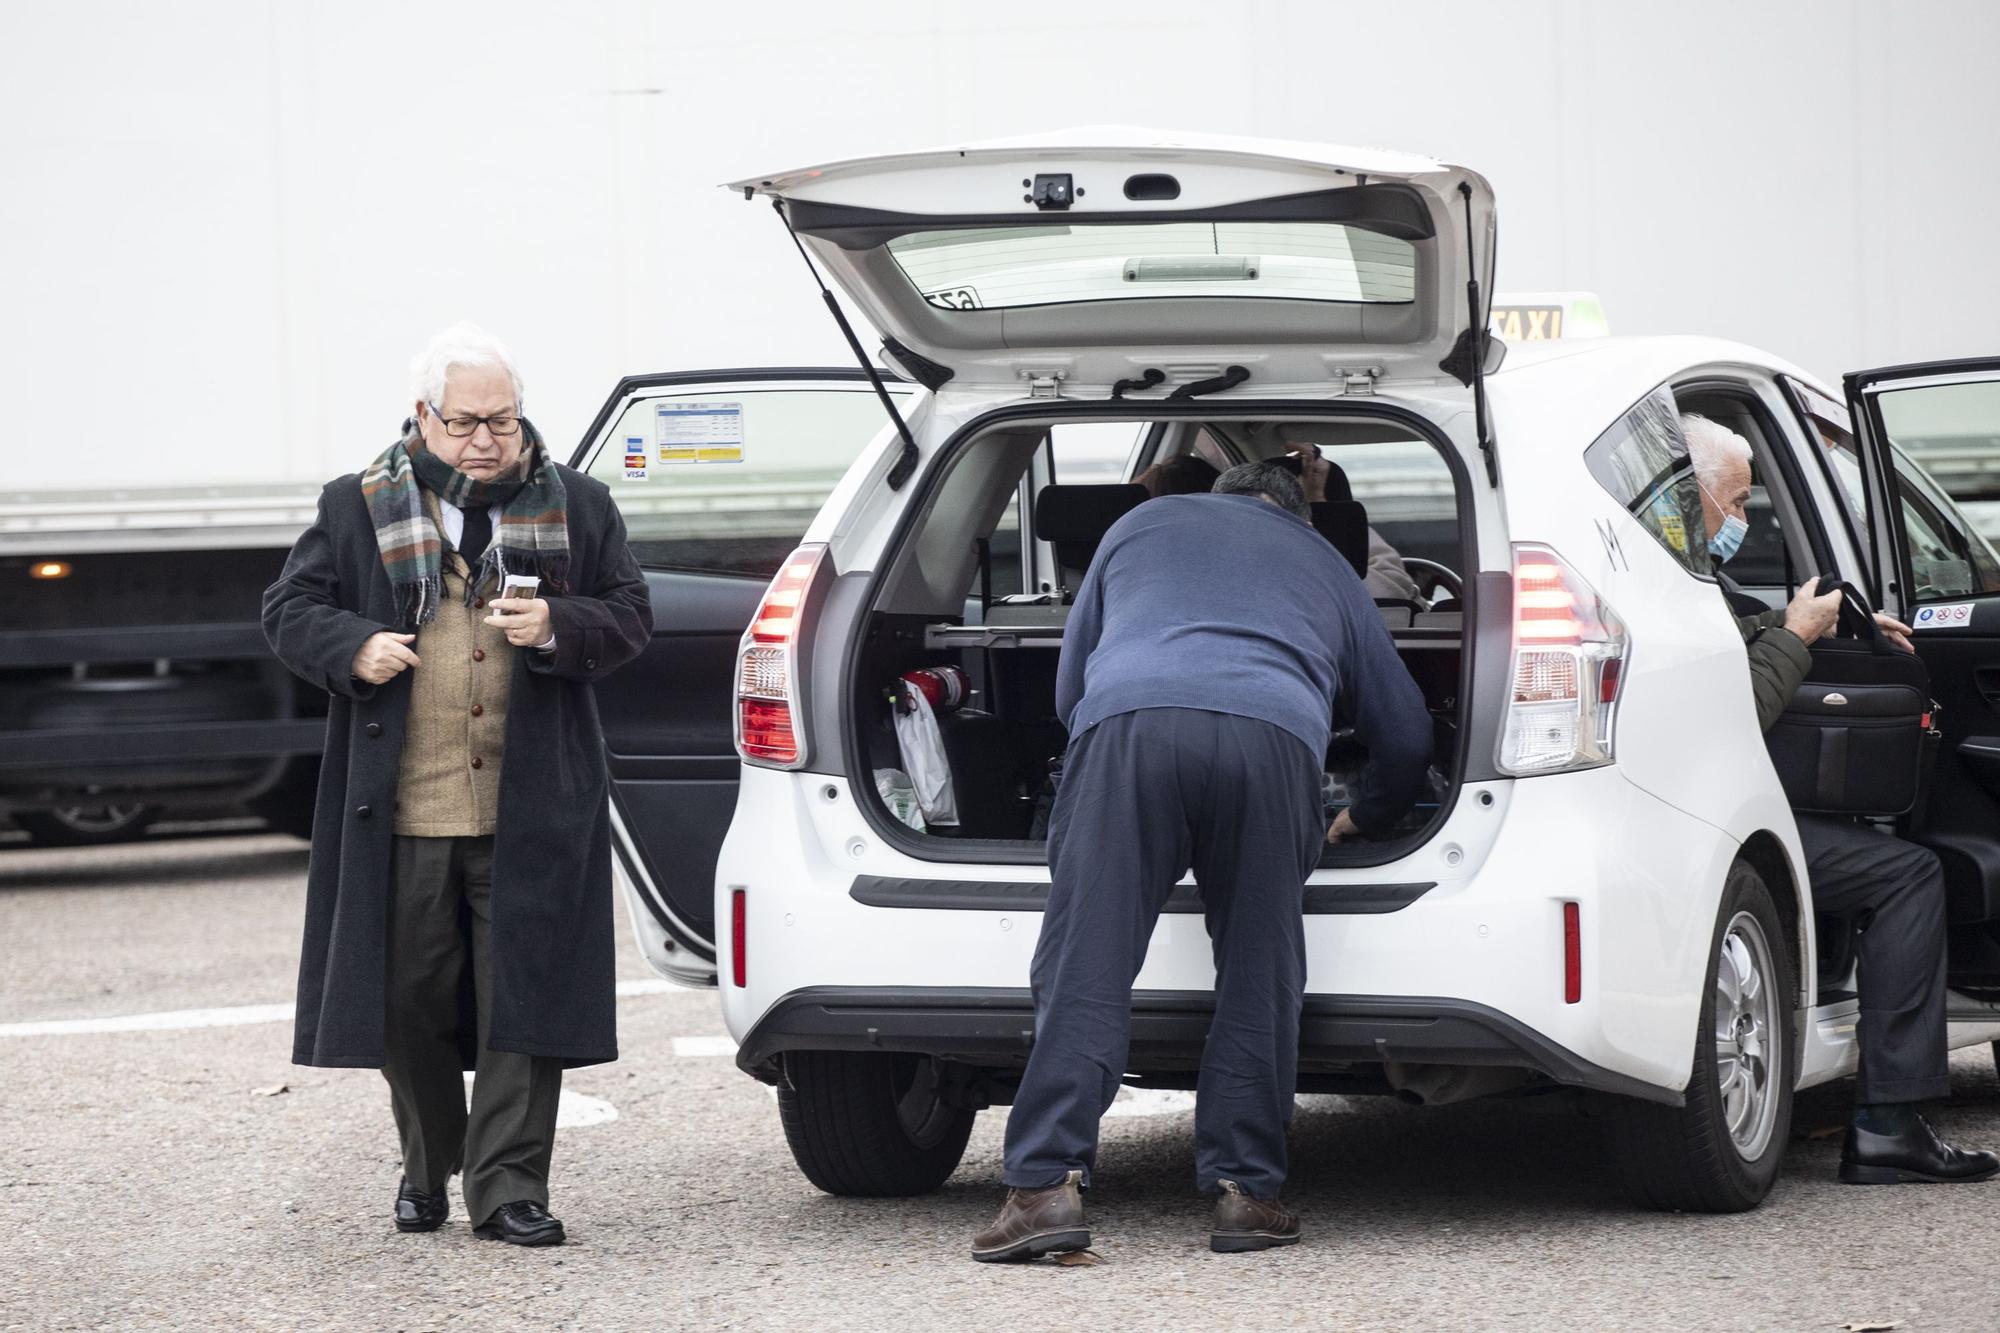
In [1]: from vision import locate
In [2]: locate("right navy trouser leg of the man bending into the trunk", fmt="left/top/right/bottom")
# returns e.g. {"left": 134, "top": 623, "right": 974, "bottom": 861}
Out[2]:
{"left": 1194, "top": 715, "right": 1326, "bottom": 1199}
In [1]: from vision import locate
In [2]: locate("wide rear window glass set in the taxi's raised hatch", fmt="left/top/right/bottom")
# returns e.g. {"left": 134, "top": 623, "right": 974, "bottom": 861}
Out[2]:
{"left": 888, "top": 222, "right": 1416, "bottom": 310}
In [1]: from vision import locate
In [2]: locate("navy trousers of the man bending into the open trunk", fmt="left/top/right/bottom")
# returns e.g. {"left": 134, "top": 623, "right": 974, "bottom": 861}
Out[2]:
{"left": 1004, "top": 709, "right": 1326, "bottom": 1199}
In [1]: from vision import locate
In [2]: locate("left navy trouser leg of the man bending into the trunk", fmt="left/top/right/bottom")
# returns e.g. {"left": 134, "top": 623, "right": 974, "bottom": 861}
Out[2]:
{"left": 1002, "top": 709, "right": 1200, "bottom": 1189}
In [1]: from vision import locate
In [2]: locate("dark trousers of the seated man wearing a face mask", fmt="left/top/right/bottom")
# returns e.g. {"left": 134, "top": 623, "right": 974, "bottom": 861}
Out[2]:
{"left": 1798, "top": 815, "right": 1952, "bottom": 1105}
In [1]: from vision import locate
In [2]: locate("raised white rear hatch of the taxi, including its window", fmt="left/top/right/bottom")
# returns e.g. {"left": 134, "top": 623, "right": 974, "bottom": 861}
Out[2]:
{"left": 732, "top": 126, "right": 1498, "bottom": 396}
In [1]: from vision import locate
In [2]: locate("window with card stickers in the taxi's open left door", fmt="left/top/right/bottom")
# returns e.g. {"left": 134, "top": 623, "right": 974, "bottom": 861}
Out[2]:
{"left": 584, "top": 380, "right": 908, "bottom": 578}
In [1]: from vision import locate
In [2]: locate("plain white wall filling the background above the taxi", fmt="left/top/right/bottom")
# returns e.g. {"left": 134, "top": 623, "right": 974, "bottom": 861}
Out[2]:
{"left": 0, "top": 0, "right": 2000, "bottom": 488}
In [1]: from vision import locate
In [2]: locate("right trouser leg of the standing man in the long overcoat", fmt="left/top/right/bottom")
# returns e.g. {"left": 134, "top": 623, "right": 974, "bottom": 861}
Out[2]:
{"left": 460, "top": 839, "right": 562, "bottom": 1227}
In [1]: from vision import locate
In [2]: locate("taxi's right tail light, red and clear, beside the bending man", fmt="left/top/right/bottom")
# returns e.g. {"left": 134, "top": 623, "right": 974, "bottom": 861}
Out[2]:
{"left": 1498, "top": 546, "right": 1628, "bottom": 777}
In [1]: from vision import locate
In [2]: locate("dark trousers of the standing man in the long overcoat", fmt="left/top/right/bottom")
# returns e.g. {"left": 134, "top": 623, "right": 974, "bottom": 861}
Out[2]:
{"left": 382, "top": 837, "right": 562, "bottom": 1227}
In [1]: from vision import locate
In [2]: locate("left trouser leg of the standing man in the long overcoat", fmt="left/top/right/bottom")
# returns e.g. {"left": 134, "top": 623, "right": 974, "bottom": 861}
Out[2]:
{"left": 382, "top": 837, "right": 466, "bottom": 1193}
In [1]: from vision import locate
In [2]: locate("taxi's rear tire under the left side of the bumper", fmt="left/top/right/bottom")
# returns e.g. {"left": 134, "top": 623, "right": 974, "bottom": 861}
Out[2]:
{"left": 778, "top": 1051, "right": 974, "bottom": 1199}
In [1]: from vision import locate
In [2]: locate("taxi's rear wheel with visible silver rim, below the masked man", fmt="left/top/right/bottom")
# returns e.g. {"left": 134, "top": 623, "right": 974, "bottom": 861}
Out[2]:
{"left": 1608, "top": 861, "right": 1798, "bottom": 1213}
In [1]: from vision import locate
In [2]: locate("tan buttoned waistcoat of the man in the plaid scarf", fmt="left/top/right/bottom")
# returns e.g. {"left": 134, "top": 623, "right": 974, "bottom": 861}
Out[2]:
{"left": 396, "top": 492, "right": 516, "bottom": 839}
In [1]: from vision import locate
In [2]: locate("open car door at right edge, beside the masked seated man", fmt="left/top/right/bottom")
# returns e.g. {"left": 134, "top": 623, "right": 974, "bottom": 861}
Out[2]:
{"left": 1820, "top": 358, "right": 2000, "bottom": 1001}
